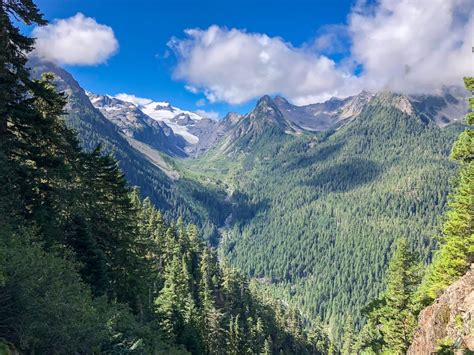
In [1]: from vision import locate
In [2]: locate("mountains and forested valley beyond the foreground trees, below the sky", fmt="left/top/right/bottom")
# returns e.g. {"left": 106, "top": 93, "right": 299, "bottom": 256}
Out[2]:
{"left": 30, "top": 60, "right": 467, "bottom": 338}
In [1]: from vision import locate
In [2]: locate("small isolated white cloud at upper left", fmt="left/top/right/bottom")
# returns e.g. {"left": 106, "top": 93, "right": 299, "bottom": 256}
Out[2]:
{"left": 33, "top": 13, "right": 118, "bottom": 65}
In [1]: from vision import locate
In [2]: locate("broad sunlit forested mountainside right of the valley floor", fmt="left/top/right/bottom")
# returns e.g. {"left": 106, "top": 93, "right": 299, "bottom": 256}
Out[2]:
{"left": 182, "top": 93, "right": 461, "bottom": 340}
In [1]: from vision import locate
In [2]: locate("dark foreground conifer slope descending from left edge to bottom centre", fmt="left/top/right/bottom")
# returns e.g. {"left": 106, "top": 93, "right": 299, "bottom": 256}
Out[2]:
{"left": 0, "top": 0, "right": 329, "bottom": 354}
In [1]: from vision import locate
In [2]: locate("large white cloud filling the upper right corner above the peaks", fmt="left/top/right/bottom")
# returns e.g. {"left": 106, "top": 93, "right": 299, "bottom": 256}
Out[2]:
{"left": 349, "top": 0, "right": 474, "bottom": 93}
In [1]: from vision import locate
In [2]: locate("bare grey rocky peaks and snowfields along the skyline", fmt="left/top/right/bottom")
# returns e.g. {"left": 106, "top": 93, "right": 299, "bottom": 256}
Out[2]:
{"left": 86, "top": 81, "right": 466, "bottom": 157}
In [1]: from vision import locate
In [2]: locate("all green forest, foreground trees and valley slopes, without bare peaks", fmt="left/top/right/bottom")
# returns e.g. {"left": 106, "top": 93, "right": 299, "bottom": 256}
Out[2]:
{"left": 0, "top": 0, "right": 474, "bottom": 354}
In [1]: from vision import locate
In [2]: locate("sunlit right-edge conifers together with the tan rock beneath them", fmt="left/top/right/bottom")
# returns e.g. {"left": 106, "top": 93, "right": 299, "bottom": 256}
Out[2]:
{"left": 358, "top": 77, "right": 474, "bottom": 354}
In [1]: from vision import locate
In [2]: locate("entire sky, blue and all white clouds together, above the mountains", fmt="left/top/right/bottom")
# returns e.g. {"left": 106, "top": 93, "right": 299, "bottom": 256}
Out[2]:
{"left": 27, "top": 0, "right": 474, "bottom": 117}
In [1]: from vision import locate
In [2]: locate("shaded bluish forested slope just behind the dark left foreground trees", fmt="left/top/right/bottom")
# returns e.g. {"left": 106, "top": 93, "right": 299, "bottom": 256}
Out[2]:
{"left": 28, "top": 57, "right": 228, "bottom": 242}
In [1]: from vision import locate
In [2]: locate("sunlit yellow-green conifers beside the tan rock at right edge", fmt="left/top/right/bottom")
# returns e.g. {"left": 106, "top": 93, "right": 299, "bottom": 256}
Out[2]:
{"left": 356, "top": 78, "right": 474, "bottom": 354}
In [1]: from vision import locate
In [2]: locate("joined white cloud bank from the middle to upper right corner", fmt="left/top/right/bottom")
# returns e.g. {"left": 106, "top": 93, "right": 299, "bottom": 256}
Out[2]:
{"left": 168, "top": 0, "right": 474, "bottom": 104}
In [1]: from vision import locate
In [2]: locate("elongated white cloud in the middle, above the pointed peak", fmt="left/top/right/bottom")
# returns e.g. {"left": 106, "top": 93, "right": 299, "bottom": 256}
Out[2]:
{"left": 169, "top": 26, "right": 354, "bottom": 104}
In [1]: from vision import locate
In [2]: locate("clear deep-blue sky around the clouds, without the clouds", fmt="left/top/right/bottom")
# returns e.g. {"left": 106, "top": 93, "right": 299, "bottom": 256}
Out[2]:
{"left": 31, "top": 0, "right": 351, "bottom": 114}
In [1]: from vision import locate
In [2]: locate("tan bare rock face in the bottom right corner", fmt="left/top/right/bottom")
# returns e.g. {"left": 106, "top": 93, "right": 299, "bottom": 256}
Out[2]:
{"left": 408, "top": 264, "right": 474, "bottom": 355}
